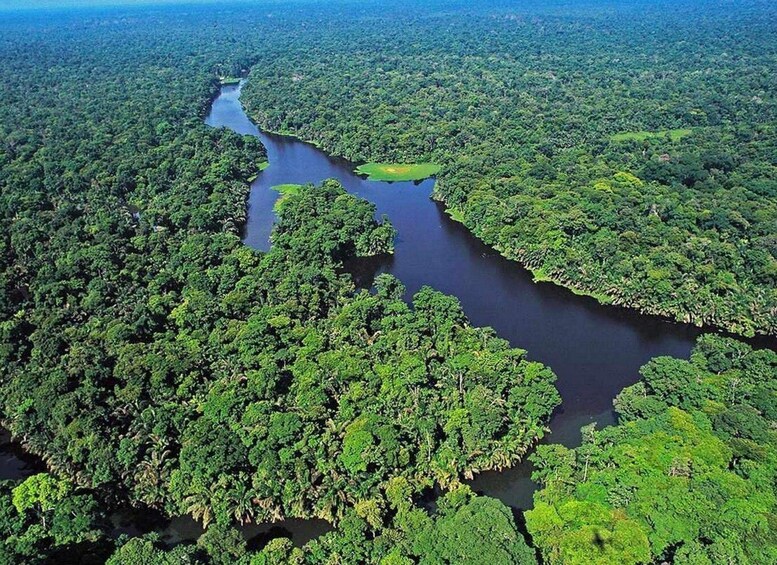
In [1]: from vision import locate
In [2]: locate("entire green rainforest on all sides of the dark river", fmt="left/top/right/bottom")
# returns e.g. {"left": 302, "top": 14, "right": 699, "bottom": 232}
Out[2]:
{"left": 0, "top": 0, "right": 777, "bottom": 565}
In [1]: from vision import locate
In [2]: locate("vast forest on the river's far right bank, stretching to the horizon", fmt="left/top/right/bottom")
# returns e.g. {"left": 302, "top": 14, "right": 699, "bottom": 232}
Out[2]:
{"left": 244, "top": 1, "right": 777, "bottom": 335}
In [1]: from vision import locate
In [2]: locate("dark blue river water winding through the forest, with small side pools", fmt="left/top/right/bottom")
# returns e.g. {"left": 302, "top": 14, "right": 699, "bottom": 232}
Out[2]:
{"left": 0, "top": 81, "right": 774, "bottom": 547}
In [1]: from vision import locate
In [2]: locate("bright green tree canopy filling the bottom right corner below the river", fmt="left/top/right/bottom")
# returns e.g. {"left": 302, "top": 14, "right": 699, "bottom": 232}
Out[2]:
{"left": 526, "top": 336, "right": 777, "bottom": 564}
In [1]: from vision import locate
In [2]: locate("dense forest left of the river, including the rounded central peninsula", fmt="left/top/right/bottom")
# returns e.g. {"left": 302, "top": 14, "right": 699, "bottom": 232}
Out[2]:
{"left": 0, "top": 8, "right": 559, "bottom": 562}
